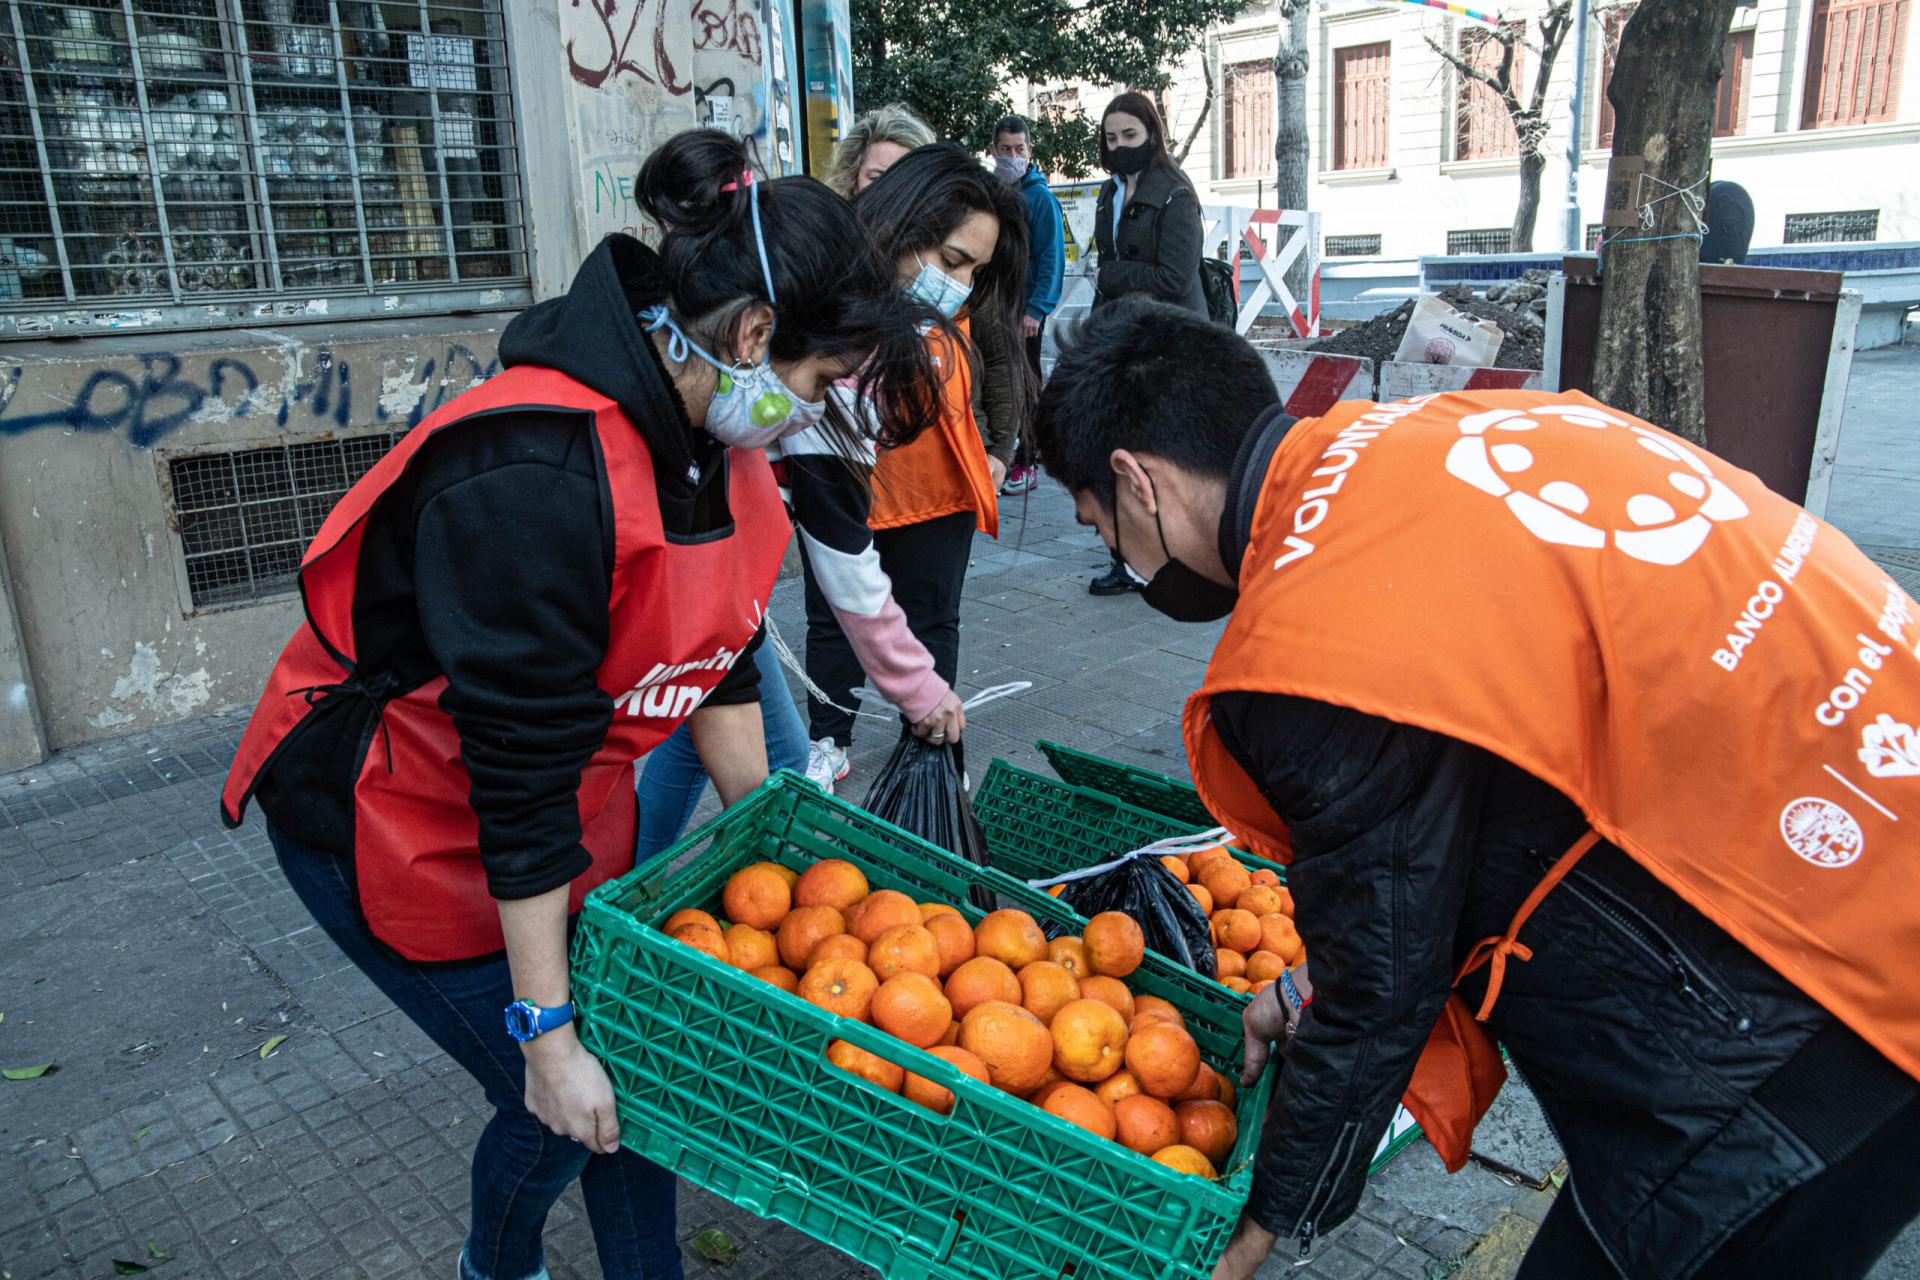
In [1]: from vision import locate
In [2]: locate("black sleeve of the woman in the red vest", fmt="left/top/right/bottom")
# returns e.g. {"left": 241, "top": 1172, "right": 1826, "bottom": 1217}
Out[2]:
{"left": 415, "top": 462, "right": 612, "bottom": 898}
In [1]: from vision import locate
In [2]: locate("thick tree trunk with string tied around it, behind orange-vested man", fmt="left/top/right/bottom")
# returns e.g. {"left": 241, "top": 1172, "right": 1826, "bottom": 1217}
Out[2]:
{"left": 1594, "top": 0, "right": 1738, "bottom": 443}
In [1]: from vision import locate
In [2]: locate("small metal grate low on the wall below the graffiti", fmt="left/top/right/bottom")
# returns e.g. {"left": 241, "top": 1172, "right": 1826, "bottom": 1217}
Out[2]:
{"left": 167, "top": 432, "right": 399, "bottom": 608}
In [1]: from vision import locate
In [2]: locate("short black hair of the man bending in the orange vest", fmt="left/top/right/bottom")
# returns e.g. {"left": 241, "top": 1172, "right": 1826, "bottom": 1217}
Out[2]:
{"left": 1033, "top": 294, "right": 1281, "bottom": 510}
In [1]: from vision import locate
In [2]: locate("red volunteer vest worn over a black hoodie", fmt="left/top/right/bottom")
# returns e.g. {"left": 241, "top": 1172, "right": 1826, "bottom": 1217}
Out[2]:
{"left": 221, "top": 367, "right": 789, "bottom": 961}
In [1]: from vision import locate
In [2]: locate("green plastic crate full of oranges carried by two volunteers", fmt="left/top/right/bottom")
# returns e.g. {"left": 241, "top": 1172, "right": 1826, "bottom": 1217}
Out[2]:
{"left": 572, "top": 773, "right": 1273, "bottom": 1280}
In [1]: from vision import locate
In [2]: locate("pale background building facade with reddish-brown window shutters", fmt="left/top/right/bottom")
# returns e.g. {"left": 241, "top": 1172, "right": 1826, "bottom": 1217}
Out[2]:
{"left": 1029, "top": 0, "right": 1920, "bottom": 259}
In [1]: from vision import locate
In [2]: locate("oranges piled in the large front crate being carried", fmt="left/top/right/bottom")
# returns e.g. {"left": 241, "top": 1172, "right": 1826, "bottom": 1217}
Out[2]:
{"left": 662, "top": 858, "right": 1238, "bottom": 1178}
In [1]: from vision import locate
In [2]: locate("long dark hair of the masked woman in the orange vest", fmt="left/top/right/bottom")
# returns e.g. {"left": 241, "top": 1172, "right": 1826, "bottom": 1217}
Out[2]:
{"left": 852, "top": 142, "right": 1035, "bottom": 435}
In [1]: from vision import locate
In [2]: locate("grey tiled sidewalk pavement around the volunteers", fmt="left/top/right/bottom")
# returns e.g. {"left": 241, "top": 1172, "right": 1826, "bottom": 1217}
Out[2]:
{"left": 0, "top": 349, "right": 1920, "bottom": 1280}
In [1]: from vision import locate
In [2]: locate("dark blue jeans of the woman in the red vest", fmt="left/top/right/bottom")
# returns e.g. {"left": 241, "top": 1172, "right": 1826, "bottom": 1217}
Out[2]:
{"left": 267, "top": 823, "right": 682, "bottom": 1280}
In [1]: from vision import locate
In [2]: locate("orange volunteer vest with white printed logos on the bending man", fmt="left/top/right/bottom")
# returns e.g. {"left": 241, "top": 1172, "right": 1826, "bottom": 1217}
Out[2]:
{"left": 1185, "top": 391, "right": 1920, "bottom": 1165}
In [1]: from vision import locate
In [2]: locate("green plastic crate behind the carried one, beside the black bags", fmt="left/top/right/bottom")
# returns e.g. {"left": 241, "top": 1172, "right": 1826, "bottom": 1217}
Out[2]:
{"left": 973, "top": 759, "right": 1286, "bottom": 885}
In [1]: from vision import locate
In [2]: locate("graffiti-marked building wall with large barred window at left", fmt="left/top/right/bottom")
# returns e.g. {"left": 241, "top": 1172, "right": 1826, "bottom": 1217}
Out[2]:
{"left": 0, "top": 0, "right": 801, "bottom": 771}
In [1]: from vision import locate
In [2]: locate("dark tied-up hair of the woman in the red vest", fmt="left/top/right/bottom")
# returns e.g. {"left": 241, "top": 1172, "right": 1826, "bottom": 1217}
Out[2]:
{"left": 634, "top": 129, "right": 939, "bottom": 443}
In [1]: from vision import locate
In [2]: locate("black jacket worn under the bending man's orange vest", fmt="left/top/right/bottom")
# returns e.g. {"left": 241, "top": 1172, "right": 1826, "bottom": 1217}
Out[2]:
{"left": 1213, "top": 411, "right": 1920, "bottom": 1280}
